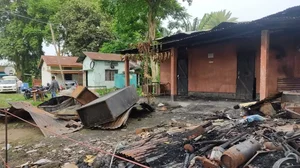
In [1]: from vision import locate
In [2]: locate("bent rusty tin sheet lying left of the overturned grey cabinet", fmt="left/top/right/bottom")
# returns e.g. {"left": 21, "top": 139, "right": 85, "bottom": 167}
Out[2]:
{"left": 9, "top": 102, "right": 80, "bottom": 137}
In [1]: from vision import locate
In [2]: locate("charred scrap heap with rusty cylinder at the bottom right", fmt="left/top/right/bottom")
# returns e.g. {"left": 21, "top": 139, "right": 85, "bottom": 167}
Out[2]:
{"left": 98, "top": 93, "right": 300, "bottom": 168}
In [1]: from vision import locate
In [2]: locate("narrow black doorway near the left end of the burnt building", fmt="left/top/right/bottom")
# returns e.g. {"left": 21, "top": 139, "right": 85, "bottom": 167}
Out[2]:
{"left": 177, "top": 48, "right": 188, "bottom": 96}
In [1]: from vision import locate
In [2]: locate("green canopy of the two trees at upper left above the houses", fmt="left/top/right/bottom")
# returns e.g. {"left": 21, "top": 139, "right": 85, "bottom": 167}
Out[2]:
{"left": 0, "top": 0, "right": 111, "bottom": 80}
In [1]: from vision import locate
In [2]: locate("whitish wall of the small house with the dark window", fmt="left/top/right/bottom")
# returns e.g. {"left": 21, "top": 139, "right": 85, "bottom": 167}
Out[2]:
{"left": 83, "top": 57, "right": 124, "bottom": 88}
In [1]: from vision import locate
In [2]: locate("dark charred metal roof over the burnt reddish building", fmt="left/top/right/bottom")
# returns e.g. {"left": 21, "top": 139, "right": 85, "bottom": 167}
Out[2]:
{"left": 119, "top": 6, "right": 300, "bottom": 54}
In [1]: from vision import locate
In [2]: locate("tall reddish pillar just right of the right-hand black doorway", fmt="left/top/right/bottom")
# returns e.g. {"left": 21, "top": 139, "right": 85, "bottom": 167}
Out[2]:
{"left": 259, "top": 30, "right": 270, "bottom": 100}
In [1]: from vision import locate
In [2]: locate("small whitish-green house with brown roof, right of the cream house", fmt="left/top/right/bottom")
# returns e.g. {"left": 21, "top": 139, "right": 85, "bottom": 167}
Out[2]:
{"left": 77, "top": 52, "right": 124, "bottom": 88}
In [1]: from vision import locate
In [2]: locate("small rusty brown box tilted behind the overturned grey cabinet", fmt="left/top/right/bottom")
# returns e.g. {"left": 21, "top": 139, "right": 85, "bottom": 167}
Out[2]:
{"left": 72, "top": 86, "right": 98, "bottom": 105}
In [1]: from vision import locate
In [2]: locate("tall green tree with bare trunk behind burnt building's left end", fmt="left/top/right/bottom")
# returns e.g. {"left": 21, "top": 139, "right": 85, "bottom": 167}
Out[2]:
{"left": 102, "top": 0, "right": 190, "bottom": 81}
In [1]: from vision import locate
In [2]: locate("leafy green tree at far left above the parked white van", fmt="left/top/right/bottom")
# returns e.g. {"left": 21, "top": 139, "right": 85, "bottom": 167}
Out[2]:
{"left": 0, "top": 0, "right": 52, "bottom": 76}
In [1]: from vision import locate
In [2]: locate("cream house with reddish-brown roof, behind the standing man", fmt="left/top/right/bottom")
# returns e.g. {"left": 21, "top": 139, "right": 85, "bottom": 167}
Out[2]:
{"left": 39, "top": 56, "right": 83, "bottom": 86}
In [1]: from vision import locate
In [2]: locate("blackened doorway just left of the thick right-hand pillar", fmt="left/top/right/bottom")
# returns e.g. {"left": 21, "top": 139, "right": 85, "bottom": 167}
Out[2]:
{"left": 236, "top": 51, "right": 256, "bottom": 100}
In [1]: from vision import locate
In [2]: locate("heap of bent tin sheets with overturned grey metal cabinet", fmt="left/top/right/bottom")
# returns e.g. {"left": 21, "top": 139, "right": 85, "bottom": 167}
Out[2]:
{"left": 3, "top": 86, "right": 153, "bottom": 137}
